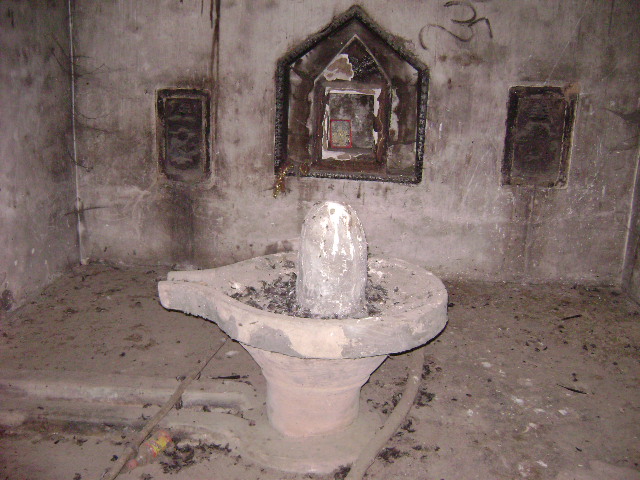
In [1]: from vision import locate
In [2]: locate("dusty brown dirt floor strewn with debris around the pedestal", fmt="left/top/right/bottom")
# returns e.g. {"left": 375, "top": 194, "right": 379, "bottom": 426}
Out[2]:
{"left": 0, "top": 265, "right": 640, "bottom": 480}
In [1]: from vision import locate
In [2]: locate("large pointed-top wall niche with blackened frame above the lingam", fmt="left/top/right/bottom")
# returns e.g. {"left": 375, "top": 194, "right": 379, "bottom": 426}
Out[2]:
{"left": 275, "top": 6, "right": 428, "bottom": 183}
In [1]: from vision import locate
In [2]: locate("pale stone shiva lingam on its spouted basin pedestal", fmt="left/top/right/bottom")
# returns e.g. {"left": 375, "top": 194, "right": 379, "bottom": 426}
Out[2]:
{"left": 158, "top": 202, "right": 447, "bottom": 471}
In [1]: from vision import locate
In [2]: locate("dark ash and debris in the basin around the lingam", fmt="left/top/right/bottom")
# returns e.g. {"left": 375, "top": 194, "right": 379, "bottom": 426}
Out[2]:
{"left": 229, "top": 271, "right": 389, "bottom": 318}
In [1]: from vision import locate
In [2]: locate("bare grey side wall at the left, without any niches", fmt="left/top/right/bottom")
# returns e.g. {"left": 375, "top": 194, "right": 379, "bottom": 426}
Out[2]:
{"left": 0, "top": 0, "right": 78, "bottom": 317}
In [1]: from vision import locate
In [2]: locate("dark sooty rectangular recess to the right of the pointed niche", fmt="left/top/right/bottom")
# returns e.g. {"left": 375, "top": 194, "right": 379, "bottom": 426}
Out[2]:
{"left": 502, "top": 86, "right": 577, "bottom": 188}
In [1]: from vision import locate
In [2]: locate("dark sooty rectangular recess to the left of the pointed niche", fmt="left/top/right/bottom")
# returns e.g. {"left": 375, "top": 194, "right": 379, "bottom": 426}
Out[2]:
{"left": 156, "top": 89, "right": 210, "bottom": 184}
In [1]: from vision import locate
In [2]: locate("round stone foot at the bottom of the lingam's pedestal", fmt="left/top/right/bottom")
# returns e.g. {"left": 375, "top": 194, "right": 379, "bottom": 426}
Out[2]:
{"left": 238, "top": 402, "right": 382, "bottom": 474}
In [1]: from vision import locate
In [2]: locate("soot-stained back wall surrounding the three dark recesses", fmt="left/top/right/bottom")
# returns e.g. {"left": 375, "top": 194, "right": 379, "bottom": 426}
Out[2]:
{"left": 74, "top": 0, "right": 640, "bottom": 283}
